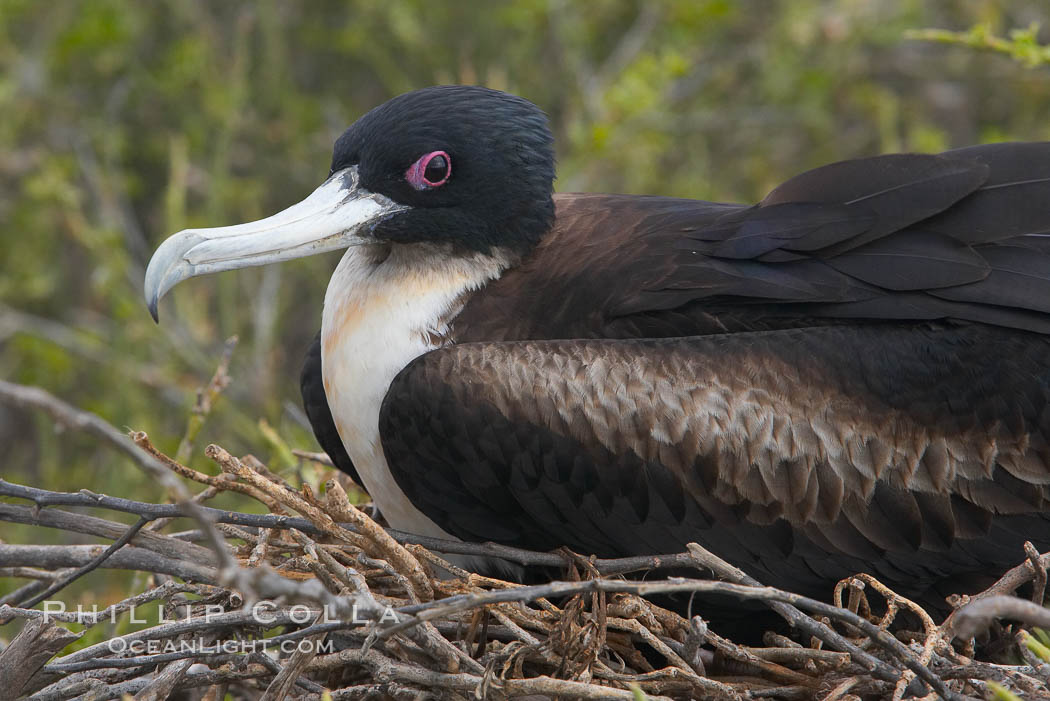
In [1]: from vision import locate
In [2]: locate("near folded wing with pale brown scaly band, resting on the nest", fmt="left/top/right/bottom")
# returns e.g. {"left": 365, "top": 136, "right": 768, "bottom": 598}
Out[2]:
{"left": 380, "top": 324, "right": 1050, "bottom": 596}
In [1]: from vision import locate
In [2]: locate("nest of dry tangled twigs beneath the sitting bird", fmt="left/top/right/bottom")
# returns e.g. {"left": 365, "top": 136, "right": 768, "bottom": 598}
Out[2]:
{"left": 0, "top": 368, "right": 1050, "bottom": 701}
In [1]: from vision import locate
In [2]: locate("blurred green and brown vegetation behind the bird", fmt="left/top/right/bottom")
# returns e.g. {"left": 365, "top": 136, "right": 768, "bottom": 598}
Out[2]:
{"left": 0, "top": 0, "right": 1050, "bottom": 598}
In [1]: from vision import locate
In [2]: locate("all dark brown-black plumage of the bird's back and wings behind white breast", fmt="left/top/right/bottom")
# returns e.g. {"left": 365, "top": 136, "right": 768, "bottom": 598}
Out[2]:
{"left": 305, "top": 144, "right": 1050, "bottom": 595}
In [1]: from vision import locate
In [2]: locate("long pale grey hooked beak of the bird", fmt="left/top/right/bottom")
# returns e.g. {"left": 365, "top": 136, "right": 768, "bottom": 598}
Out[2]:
{"left": 144, "top": 166, "right": 408, "bottom": 321}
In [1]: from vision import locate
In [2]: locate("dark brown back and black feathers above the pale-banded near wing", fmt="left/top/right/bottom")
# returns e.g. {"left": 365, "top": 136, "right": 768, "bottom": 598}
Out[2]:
{"left": 456, "top": 143, "right": 1050, "bottom": 341}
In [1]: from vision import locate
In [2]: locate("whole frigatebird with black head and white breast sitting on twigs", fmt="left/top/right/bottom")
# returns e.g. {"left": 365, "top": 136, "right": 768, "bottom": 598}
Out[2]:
{"left": 145, "top": 86, "right": 1050, "bottom": 596}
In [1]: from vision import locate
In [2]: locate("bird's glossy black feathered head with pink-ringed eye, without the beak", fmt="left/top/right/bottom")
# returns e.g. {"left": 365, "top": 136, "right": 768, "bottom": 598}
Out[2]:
{"left": 332, "top": 85, "right": 554, "bottom": 253}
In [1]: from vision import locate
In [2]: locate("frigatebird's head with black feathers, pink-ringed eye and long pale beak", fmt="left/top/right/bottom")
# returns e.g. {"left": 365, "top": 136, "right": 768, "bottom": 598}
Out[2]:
{"left": 145, "top": 86, "right": 554, "bottom": 319}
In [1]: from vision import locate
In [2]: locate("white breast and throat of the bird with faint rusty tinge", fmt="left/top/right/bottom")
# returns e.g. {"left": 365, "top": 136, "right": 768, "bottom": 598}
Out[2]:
{"left": 321, "top": 245, "right": 504, "bottom": 537}
